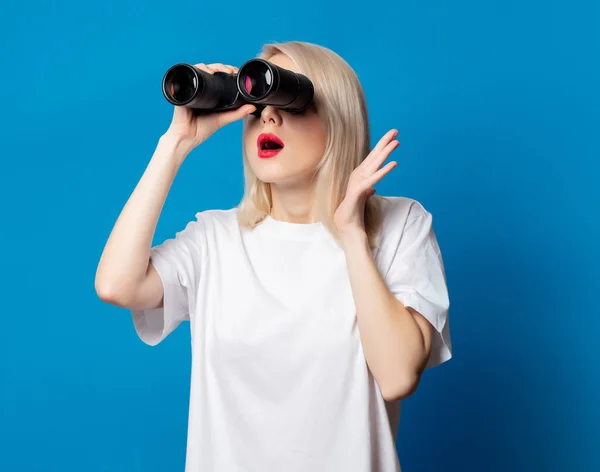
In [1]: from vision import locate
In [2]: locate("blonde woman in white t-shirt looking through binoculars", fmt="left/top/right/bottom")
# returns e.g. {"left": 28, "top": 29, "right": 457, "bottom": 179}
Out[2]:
{"left": 96, "top": 42, "right": 451, "bottom": 472}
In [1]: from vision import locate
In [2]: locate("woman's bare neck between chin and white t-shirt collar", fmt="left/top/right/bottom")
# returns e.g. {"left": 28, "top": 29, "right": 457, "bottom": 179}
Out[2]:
{"left": 271, "top": 183, "right": 317, "bottom": 224}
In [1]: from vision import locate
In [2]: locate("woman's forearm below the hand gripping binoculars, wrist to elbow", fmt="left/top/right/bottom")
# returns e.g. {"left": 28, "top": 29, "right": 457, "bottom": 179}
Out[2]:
{"left": 95, "top": 135, "right": 188, "bottom": 299}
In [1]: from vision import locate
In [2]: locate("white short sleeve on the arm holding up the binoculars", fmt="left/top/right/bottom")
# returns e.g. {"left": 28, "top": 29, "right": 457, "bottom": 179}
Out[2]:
{"left": 131, "top": 214, "right": 206, "bottom": 346}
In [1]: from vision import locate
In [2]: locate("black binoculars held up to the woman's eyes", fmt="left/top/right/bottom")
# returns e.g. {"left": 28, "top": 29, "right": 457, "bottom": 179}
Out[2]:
{"left": 162, "top": 59, "right": 314, "bottom": 115}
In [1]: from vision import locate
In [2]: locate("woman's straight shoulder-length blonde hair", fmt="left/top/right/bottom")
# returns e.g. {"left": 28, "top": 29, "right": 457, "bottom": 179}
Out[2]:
{"left": 238, "top": 41, "right": 382, "bottom": 248}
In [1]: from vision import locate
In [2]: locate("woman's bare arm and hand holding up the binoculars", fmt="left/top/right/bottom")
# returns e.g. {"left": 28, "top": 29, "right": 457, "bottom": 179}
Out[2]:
{"left": 94, "top": 63, "right": 256, "bottom": 309}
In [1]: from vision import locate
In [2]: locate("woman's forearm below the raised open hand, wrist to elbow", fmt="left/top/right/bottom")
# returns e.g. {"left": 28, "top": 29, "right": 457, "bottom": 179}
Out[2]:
{"left": 343, "top": 233, "right": 428, "bottom": 399}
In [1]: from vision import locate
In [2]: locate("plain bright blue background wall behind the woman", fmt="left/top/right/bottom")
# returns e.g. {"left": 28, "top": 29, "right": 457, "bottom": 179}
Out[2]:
{"left": 0, "top": 0, "right": 600, "bottom": 472}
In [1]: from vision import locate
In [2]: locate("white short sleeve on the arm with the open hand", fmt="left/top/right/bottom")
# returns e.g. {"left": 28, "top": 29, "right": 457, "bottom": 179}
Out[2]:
{"left": 385, "top": 207, "right": 452, "bottom": 368}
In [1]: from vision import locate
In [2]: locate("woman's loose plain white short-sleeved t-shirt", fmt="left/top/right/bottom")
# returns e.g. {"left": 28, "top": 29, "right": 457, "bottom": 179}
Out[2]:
{"left": 132, "top": 197, "right": 451, "bottom": 472}
